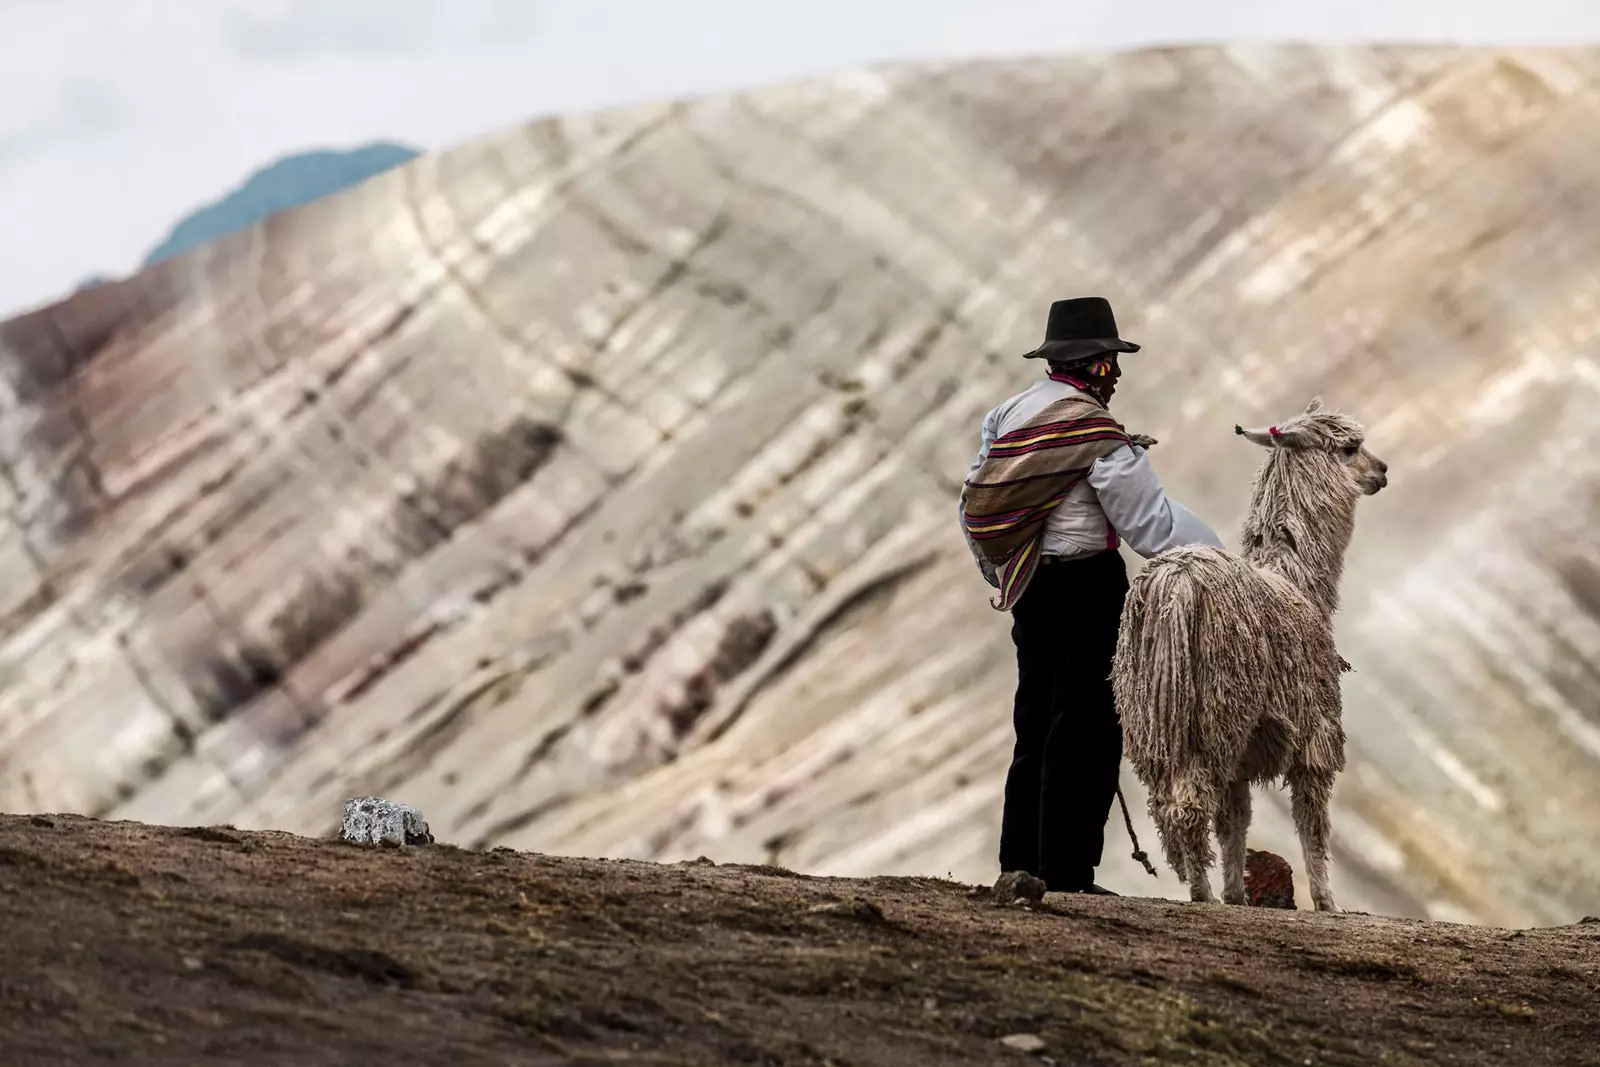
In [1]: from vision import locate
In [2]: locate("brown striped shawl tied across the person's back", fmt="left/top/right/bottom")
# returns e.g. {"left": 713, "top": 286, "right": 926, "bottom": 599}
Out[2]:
{"left": 962, "top": 397, "right": 1130, "bottom": 611}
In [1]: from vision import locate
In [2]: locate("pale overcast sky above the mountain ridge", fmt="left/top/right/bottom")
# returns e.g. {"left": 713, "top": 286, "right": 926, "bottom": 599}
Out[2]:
{"left": 9, "top": 0, "right": 1600, "bottom": 317}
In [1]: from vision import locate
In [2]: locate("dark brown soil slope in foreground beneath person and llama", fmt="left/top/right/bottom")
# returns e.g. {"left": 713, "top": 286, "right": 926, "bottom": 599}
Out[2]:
{"left": 0, "top": 816, "right": 1600, "bottom": 1067}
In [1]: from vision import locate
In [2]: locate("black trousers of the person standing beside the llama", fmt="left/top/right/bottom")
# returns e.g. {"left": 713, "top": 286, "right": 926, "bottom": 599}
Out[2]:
{"left": 1000, "top": 550, "right": 1128, "bottom": 893}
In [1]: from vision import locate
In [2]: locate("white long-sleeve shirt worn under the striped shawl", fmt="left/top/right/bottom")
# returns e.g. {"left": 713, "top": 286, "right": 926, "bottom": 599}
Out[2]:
{"left": 962, "top": 378, "right": 1224, "bottom": 584}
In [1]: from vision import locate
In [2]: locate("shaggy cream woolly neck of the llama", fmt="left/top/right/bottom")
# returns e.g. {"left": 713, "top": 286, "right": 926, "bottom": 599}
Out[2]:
{"left": 1240, "top": 450, "right": 1360, "bottom": 619}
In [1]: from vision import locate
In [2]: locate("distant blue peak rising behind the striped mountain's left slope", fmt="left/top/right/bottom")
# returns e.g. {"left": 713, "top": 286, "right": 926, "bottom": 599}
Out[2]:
{"left": 144, "top": 141, "right": 421, "bottom": 267}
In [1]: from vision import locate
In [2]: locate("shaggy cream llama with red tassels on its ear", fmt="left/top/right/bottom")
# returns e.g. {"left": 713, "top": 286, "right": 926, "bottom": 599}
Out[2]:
{"left": 1112, "top": 398, "right": 1389, "bottom": 912}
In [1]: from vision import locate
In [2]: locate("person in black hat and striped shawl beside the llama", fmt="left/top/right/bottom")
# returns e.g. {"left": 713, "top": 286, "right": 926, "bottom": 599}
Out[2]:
{"left": 962, "top": 296, "right": 1222, "bottom": 896}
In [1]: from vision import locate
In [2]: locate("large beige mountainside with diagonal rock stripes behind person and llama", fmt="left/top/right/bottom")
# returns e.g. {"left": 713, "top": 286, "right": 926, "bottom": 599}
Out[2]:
{"left": 0, "top": 48, "right": 1600, "bottom": 923}
